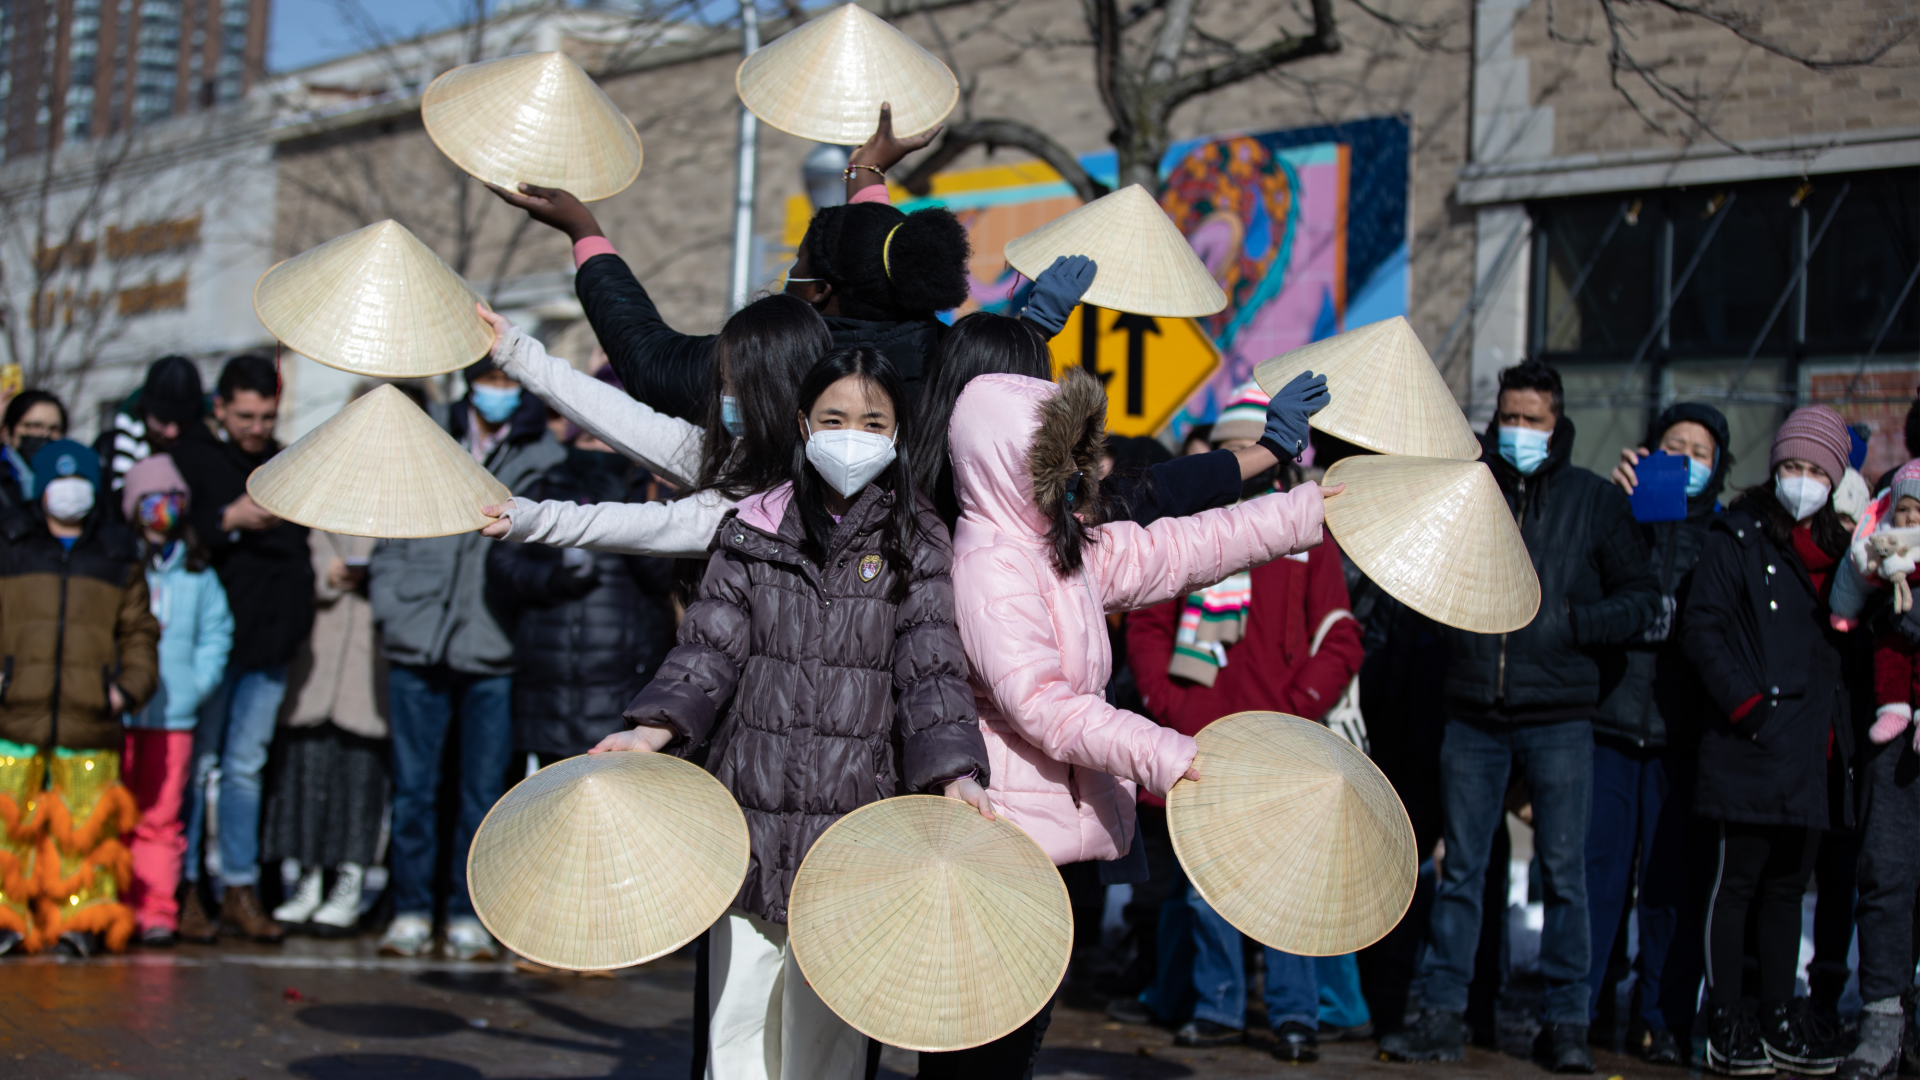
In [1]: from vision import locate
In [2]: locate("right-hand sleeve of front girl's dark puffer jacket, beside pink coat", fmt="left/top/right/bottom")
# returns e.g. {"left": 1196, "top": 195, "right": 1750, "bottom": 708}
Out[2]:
{"left": 893, "top": 511, "right": 989, "bottom": 794}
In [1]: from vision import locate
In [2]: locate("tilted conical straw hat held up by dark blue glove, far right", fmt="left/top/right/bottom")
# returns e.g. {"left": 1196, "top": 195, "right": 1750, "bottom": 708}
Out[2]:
{"left": 1254, "top": 315, "right": 1480, "bottom": 461}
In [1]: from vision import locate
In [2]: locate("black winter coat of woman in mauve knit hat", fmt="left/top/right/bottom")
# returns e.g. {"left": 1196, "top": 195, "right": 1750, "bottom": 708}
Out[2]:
{"left": 1680, "top": 503, "right": 1853, "bottom": 828}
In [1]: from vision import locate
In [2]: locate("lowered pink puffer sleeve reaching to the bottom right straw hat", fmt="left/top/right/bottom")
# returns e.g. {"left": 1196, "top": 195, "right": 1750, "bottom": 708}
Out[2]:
{"left": 956, "top": 548, "right": 1196, "bottom": 796}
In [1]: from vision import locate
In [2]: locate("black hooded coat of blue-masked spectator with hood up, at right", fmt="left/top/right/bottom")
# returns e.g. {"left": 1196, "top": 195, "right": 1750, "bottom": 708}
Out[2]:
{"left": 1594, "top": 402, "right": 1734, "bottom": 749}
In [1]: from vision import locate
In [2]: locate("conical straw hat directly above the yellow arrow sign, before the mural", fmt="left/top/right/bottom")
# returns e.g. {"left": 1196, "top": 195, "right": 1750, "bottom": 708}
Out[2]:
{"left": 1006, "top": 184, "right": 1227, "bottom": 319}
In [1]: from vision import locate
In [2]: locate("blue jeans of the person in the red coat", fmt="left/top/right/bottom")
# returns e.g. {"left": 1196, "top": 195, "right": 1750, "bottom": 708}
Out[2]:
{"left": 1140, "top": 884, "right": 1321, "bottom": 1028}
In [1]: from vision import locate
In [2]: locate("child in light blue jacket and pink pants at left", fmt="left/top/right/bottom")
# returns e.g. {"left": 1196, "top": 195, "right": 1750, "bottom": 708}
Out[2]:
{"left": 121, "top": 454, "right": 234, "bottom": 945}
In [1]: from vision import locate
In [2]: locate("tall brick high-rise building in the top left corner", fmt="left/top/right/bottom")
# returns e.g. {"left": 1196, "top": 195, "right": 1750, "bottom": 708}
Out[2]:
{"left": 0, "top": 0, "right": 271, "bottom": 158}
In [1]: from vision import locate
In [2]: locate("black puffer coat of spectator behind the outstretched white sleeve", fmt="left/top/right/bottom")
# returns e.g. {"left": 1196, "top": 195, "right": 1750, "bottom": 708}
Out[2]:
{"left": 488, "top": 452, "right": 674, "bottom": 757}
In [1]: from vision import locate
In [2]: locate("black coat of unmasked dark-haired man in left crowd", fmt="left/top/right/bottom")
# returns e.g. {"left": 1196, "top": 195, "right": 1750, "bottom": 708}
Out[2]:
{"left": 168, "top": 423, "right": 313, "bottom": 671}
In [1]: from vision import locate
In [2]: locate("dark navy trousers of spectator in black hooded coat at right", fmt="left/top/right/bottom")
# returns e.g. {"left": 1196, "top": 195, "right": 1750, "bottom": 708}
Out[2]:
{"left": 1586, "top": 738, "right": 1693, "bottom": 1032}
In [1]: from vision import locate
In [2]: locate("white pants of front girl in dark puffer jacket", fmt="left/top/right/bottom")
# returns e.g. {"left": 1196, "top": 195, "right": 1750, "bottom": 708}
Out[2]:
{"left": 707, "top": 907, "right": 866, "bottom": 1080}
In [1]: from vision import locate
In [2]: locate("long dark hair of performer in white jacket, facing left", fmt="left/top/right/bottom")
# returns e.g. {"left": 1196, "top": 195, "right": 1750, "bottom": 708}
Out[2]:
{"left": 693, "top": 292, "right": 833, "bottom": 500}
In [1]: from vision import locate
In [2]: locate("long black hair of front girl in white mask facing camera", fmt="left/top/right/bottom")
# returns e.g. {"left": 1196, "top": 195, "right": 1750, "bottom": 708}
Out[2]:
{"left": 787, "top": 346, "right": 920, "bottom": 601}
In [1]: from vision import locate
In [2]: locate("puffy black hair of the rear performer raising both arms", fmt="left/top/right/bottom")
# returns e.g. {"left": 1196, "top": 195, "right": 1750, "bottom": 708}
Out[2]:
{"left": 801, "top": 202, "right": 973, "bottom": 323}
